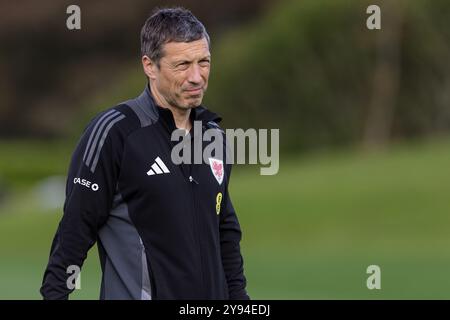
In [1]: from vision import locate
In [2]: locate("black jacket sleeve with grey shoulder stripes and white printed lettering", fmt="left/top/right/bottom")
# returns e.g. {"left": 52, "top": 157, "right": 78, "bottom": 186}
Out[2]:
{"left": 40, "top": 109, "right": 125, "bottom": 299}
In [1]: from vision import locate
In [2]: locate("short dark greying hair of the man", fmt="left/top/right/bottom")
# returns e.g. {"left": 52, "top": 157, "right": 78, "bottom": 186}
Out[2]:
{"left": 141, "top": 7, "right": 210, "bottom": 66}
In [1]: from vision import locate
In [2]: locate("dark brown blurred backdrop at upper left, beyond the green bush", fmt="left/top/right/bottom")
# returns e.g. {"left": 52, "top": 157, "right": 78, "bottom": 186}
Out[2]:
{"left": 0, "top": 0, "right": 271, "bottom": 137}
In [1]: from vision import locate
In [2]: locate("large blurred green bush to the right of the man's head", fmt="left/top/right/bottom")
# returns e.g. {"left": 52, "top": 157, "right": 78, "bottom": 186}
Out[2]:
{"left": 206, "top": 0, "right": 450, "bottom": 150}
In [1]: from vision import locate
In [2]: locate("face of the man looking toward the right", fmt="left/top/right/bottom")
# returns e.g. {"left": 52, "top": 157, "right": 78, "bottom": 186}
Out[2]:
{"left": 150, "top": 38, "right": 211, "bottom": 109}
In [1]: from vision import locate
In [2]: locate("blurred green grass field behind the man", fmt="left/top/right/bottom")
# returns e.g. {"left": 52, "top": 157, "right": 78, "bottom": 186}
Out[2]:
{"left": 0, "top": 140, "right": 450, "bottom": 299}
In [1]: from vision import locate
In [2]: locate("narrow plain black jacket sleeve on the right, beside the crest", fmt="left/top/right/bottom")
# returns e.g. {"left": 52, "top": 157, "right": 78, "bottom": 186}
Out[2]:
{"left": 220, "top": 165, "right": 250, "bottom": 300}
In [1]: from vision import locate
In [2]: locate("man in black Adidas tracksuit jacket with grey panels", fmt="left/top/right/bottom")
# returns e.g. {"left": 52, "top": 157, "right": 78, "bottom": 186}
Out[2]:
{"left": 41, "top": 8, "right": 249, "bottom": 299}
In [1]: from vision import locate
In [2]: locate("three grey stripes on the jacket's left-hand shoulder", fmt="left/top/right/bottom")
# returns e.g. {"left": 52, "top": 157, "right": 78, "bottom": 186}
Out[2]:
{"left": 83, "top": 109, "right": 125, "bottom": 173}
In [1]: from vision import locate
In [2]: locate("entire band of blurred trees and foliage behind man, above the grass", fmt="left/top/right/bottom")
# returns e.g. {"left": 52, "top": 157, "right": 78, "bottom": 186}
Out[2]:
{"left": 0, "top": 0, "right": 450, "bottom": 154}
